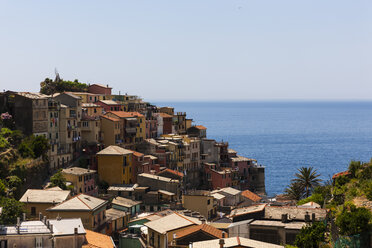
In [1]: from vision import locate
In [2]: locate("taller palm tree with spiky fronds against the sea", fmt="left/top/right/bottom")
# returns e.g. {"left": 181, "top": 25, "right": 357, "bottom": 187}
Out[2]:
{"left": 293, "top": 167, "right": 322, "bottom": 197}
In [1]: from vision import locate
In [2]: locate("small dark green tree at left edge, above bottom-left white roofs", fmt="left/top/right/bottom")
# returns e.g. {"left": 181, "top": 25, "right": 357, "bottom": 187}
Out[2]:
{"left": 0, "top": 197, "right": 24, "bottom": 225}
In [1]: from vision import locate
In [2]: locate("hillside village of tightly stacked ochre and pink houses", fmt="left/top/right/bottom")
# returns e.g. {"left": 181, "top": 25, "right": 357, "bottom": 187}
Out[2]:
{"left": 0, "top": 75, "right": 370, "bottom": 248}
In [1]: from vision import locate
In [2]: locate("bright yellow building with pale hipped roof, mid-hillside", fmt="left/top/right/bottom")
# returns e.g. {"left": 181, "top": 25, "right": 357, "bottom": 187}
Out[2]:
{"left": 97, "top": 146, "right": 133, "bottom": 185}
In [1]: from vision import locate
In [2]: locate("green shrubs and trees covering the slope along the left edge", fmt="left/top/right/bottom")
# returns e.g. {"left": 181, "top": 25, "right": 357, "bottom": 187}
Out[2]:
{"left": 0, "top": 127, "right": 49, "bottom": 224}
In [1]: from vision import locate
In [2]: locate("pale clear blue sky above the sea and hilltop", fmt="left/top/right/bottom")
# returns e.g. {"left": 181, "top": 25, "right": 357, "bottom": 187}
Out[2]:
{"left": 0, "top": 0, "right": 372, "bottom": 101}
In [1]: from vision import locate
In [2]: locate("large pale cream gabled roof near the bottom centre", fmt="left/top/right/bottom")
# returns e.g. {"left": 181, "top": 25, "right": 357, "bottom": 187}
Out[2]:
{"left": 145, "top": 213, "right": 199, "bottom": 234}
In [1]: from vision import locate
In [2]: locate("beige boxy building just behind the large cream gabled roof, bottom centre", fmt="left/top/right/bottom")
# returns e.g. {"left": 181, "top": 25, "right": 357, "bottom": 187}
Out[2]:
{"left": 182, "top": 190, "right": 217, "bottom": 220}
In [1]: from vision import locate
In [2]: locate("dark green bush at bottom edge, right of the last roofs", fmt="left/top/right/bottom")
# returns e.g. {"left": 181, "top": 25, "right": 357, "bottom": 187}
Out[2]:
{"left": 294, "top": 222, "right": 326, "bottom": 248}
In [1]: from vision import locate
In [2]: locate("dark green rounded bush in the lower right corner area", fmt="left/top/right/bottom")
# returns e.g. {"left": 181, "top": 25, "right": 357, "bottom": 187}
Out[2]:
{"left": 336, "top": 203, "right": 372, "bottom": 235}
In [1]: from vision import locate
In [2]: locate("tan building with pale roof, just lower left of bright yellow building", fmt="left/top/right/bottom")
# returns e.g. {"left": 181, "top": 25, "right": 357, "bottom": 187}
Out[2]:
{"left": 62, "top": 167, "right": 98, "bottom": 196}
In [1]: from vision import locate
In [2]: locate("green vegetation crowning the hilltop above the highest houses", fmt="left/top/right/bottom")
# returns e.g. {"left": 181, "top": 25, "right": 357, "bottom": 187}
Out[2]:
{"left": 40, "top": 76, "right": 88, "bottom": 95}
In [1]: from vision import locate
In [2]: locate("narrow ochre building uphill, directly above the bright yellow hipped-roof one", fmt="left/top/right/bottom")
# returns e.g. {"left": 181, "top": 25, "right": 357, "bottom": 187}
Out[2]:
{"left": 101, "top": 115, "right": 123, "bottom": 147}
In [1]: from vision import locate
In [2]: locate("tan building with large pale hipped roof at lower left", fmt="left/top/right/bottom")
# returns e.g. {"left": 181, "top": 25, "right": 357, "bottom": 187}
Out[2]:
{"left": 46, "top": 194, "right": 108, "bottom": 231}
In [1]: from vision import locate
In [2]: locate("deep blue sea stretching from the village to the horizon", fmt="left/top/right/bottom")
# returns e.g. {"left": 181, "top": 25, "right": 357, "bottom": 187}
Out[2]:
{"left": 154, "top": 102, "right": 372, "bottom": 195}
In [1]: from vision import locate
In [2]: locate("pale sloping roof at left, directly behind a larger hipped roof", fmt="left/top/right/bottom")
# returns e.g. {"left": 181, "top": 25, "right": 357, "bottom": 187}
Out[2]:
{"left": 19, "top": 189, "right": 70, "bottom": 204}
